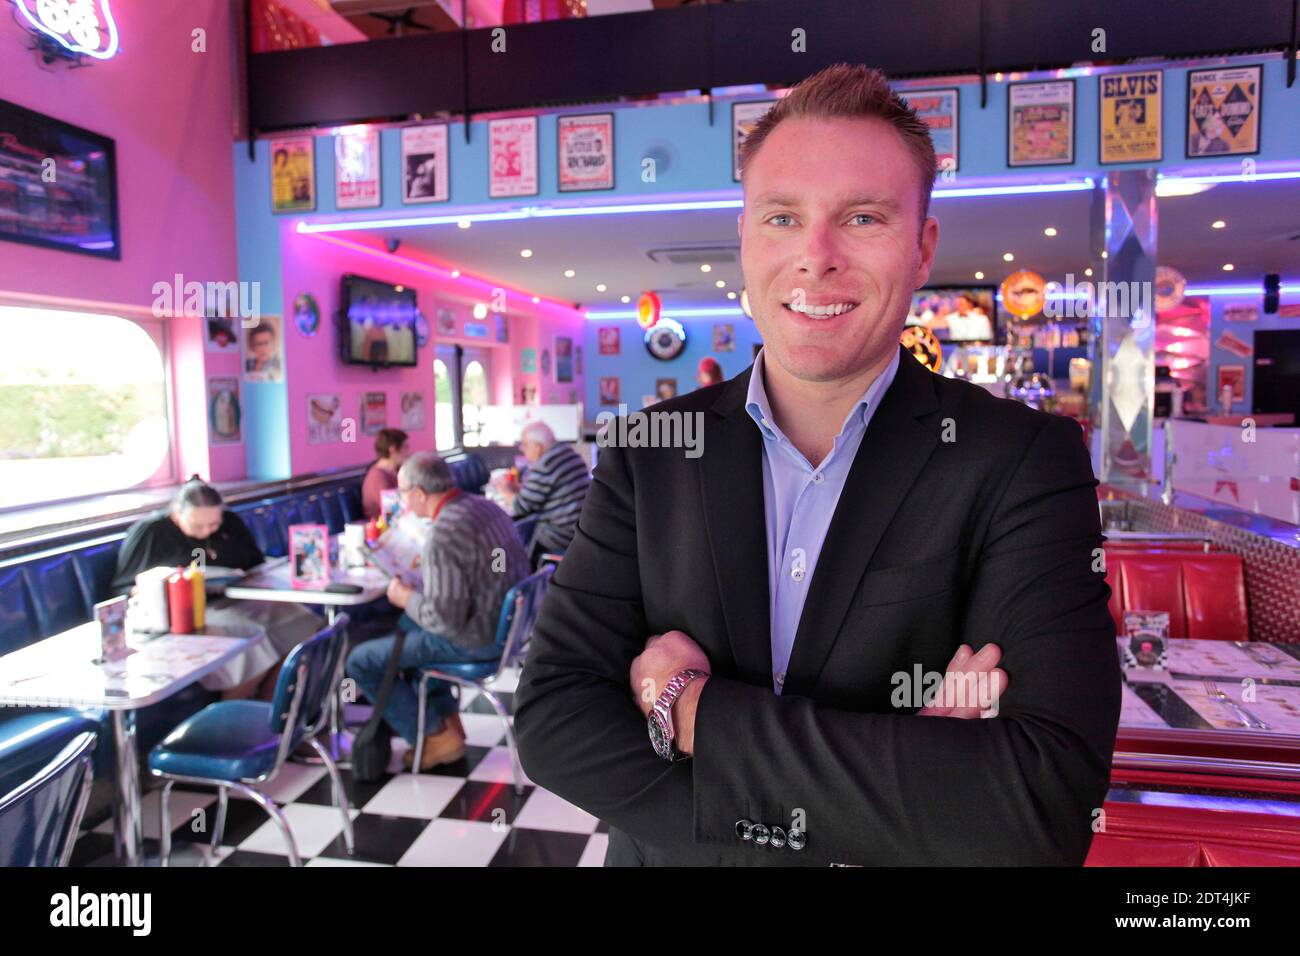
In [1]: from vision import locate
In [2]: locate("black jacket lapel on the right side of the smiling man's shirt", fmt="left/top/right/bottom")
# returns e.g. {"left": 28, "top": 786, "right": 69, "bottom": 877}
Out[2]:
{"left": 774, "top": 346, "right": 939, "bottom": 696}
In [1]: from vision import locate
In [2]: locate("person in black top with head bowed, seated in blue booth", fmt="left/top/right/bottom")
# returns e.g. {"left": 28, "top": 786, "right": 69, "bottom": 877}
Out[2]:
{"left": 112, "top": 475, "right": 325, "bottom": 700}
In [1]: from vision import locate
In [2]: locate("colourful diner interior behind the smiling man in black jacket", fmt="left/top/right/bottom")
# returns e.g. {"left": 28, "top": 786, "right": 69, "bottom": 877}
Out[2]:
{"left": 0, "top": 0, "right": 1300, "bottom": 868}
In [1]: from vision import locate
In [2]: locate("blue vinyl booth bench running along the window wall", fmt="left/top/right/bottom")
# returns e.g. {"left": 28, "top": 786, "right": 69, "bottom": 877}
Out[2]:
{"left": 0, "top": 451, "right": 489, "bottom": 816}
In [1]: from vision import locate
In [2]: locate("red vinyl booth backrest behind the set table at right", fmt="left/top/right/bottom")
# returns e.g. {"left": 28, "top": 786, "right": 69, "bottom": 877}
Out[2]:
{"left": 1106, "top": 545, "right": 1251, "bottom": 641}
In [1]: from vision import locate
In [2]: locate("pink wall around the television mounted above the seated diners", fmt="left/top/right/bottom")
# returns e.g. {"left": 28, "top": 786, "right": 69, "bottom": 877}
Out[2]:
{"left": 281, "top": 228, "right": 584, "bottom": 475}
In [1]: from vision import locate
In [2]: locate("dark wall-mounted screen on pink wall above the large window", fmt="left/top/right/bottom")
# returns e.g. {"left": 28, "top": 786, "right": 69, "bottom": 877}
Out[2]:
{"left": 0, "top": 100, "right": 122, "bottom": 259}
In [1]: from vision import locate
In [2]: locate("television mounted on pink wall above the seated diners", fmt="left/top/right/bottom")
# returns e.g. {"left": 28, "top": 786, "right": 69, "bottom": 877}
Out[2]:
{"left": 338, "top": 274, "right": 419, "bottom": 368}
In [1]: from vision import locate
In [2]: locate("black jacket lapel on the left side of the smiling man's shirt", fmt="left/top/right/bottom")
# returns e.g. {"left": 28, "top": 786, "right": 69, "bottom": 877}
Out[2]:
{"left": 699, "top": 365, "right": 772, "bottom": 685}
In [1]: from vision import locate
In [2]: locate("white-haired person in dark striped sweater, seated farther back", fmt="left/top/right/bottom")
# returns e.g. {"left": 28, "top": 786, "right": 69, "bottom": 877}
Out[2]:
{"left": 501, "top": 421, "right": 592, "bottom": 561}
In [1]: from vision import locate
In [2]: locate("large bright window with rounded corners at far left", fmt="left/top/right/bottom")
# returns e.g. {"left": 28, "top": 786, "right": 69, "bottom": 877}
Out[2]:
{"left": 0, "top": 306, "right": 173, "bottom": 509}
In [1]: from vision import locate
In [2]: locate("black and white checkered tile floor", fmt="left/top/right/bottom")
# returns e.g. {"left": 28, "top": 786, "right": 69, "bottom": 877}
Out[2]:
{"left": 73, "top": 671, "right": 607, "bottom": 866}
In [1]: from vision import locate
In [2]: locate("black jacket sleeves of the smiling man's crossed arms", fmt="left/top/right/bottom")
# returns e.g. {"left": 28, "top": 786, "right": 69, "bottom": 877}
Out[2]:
{"left": 516, "top": 419, "right": 1119, "bottom": 865}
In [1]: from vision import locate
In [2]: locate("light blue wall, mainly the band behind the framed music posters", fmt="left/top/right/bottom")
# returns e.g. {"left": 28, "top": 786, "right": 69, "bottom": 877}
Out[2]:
{"left": 235, "top": 60, "right": 1300, "bottom": 447}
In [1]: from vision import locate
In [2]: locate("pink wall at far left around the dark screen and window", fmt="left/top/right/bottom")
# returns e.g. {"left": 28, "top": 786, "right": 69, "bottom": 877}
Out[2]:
{"left": 0, "top": 0, "right": 244, "bottom": 480}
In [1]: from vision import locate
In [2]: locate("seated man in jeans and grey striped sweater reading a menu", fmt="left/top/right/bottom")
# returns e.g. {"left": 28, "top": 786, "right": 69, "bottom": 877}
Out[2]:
{"left": 347, "top": 451, "right": 529, "bottom": 770}
